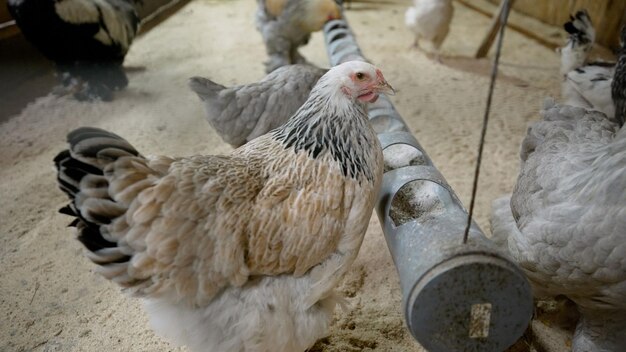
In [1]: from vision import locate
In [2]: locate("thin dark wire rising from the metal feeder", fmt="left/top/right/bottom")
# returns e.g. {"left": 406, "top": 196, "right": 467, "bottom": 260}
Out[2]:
{"left": 463, "top": 0, "right": 509, "bottom": 244}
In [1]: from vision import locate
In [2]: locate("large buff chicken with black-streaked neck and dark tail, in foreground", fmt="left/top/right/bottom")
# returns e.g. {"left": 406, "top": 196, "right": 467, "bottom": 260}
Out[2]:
{"left": 55, "top": 61, "right": 392, "bottom": 352}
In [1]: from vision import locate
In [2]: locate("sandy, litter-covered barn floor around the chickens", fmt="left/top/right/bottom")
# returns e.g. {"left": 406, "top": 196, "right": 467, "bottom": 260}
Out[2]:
{"left": 0, "top": 0, "right": 584, "bottom": 352}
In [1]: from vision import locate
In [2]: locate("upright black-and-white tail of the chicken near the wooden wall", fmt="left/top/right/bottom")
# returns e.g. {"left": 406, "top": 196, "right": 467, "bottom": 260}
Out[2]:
{"left": 561, "top": 10, "right": 596, "bottom": 75}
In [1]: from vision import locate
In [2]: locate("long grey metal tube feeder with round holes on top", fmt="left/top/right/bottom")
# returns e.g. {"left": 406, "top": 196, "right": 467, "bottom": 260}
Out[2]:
{"left": 324, "top": 14, "right": 533, "bottom": 352}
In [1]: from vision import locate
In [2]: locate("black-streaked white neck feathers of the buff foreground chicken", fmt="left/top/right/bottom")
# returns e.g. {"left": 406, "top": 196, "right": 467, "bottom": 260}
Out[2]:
{"left": 272, "top": 77, "right": 378, "bottom": 181}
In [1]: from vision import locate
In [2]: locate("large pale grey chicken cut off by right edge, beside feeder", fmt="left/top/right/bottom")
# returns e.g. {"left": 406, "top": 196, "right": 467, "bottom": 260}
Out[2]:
{"left": 491, "top": 102, "right": 626, "bottom": 352}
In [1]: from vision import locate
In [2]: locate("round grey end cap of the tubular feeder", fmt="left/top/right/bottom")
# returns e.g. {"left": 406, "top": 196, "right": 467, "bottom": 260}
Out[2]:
{"left": 405, "top": 254, "right": 533, "bottom": 352}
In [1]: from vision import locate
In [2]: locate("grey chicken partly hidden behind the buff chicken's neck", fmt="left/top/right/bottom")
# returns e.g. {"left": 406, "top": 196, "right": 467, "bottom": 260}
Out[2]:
{"left": 189, "top": 64, "right": 328, "bottom": 148}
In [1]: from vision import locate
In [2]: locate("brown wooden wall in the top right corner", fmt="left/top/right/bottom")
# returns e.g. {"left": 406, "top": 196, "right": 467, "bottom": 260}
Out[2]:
{"left": 489, "top": 0, "right": 626, "bottom": 49}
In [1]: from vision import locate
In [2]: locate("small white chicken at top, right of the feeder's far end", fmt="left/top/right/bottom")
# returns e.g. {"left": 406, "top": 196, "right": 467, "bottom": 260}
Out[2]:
{"left": 404, "top": 0, "right": 454, "bottom": 57}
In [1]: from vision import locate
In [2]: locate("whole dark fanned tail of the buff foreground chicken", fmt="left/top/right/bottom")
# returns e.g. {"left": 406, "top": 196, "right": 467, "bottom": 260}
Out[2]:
{"left": 54, "top": 127, "right": 148, "bottom": 278}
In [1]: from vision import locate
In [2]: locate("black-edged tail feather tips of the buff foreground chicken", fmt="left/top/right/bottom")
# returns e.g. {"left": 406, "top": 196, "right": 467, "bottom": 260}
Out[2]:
{"left": 54, "top": 127, "right": 141, "bottom": 268}
